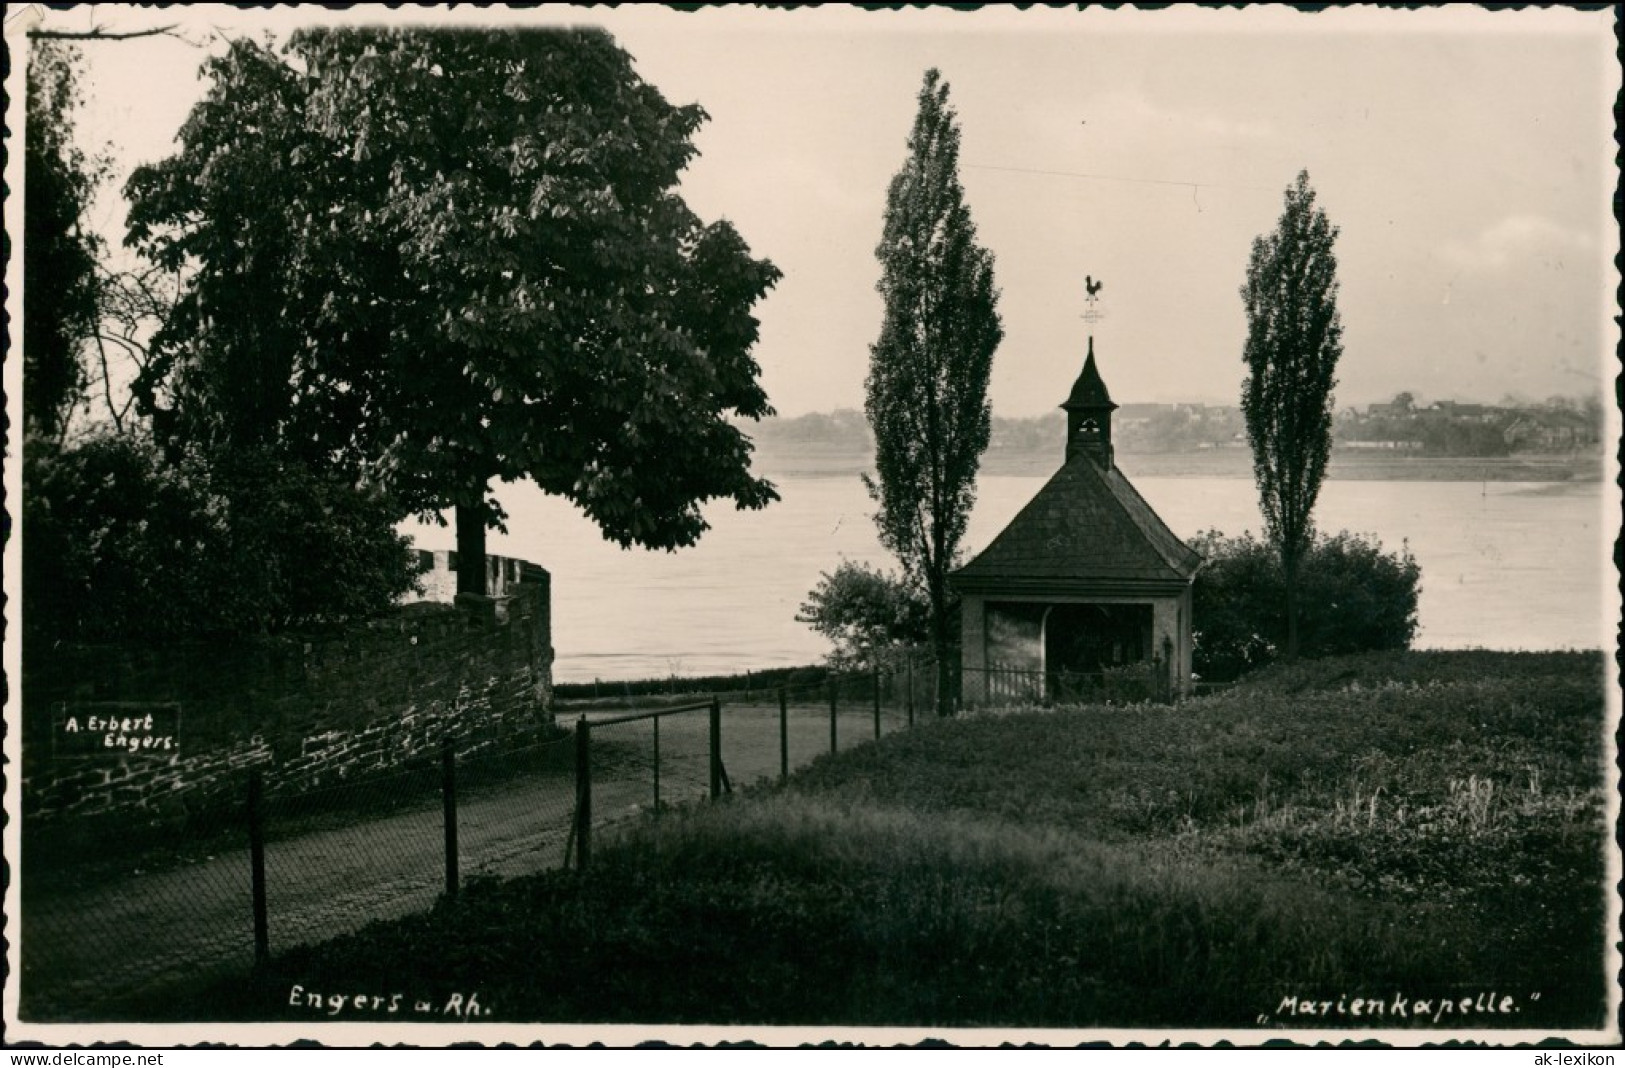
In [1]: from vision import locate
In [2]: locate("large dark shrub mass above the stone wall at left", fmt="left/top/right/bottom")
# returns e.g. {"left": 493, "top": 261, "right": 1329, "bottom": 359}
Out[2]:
{"left": 23, "top": 434, "right": 416, "bottom": 640}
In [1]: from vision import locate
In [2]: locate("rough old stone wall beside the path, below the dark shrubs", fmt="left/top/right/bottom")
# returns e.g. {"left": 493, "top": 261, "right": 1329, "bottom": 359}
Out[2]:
{"left": 21, "top": 561, "right": 553, "bottom": 821}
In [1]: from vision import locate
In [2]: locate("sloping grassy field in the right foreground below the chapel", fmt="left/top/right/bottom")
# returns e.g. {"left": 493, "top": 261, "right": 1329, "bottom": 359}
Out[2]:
{"left": 158, "top": 652, "right": 1612, "bottom": 1031}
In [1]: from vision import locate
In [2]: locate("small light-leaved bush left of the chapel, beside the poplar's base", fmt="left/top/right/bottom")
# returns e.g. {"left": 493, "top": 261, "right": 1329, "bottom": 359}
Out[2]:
{"left": 796, "top": 561, "right": 931, "bottom": 668}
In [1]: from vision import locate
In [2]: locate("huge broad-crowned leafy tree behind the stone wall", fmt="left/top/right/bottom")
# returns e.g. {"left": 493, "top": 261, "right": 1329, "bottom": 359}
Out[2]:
{"left": 130, "top": 28, "right": 778, "bottom": 590}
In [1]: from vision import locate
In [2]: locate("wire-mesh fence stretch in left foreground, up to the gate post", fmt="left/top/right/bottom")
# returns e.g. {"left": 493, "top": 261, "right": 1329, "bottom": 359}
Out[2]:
{"left": 20, "top": 728, "right": 575, "bottom": 1021}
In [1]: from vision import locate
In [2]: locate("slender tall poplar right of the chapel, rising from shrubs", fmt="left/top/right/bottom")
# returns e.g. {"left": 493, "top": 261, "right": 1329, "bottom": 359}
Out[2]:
{"left": 1242, "top": 171, "right": 1342, "bottom": 658}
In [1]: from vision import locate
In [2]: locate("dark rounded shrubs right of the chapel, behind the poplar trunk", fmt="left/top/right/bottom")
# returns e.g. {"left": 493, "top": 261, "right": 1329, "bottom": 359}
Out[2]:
{"left": 1191, "top": 530, "right": 1422, "bottom": 679}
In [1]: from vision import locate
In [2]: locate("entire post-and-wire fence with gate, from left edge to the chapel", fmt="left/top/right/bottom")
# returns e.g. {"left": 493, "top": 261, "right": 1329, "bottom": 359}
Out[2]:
{"left": 13, "top": 653, "right": 951, "bottom": 1021}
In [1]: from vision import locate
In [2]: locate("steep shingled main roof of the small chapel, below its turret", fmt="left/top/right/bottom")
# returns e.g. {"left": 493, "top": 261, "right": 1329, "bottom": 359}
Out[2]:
{"left": 954, "top": 455, "right": 1201, "bottom": 585}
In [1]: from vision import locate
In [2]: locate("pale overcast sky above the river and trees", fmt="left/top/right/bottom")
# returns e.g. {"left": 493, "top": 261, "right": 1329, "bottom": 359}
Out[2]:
{"left": 22, "top": 5, "right": 1619, "bottom": 416}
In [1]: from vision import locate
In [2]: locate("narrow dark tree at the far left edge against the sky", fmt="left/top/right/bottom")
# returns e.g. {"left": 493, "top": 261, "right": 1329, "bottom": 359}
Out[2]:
{"left": 23, "top": 41, "right": 106, "bottom": 442}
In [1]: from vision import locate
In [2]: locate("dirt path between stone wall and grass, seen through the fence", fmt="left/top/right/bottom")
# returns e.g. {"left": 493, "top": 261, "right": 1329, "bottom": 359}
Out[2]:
{"left": 20, "top": 705, "right": 904, "bottom": 1021}
